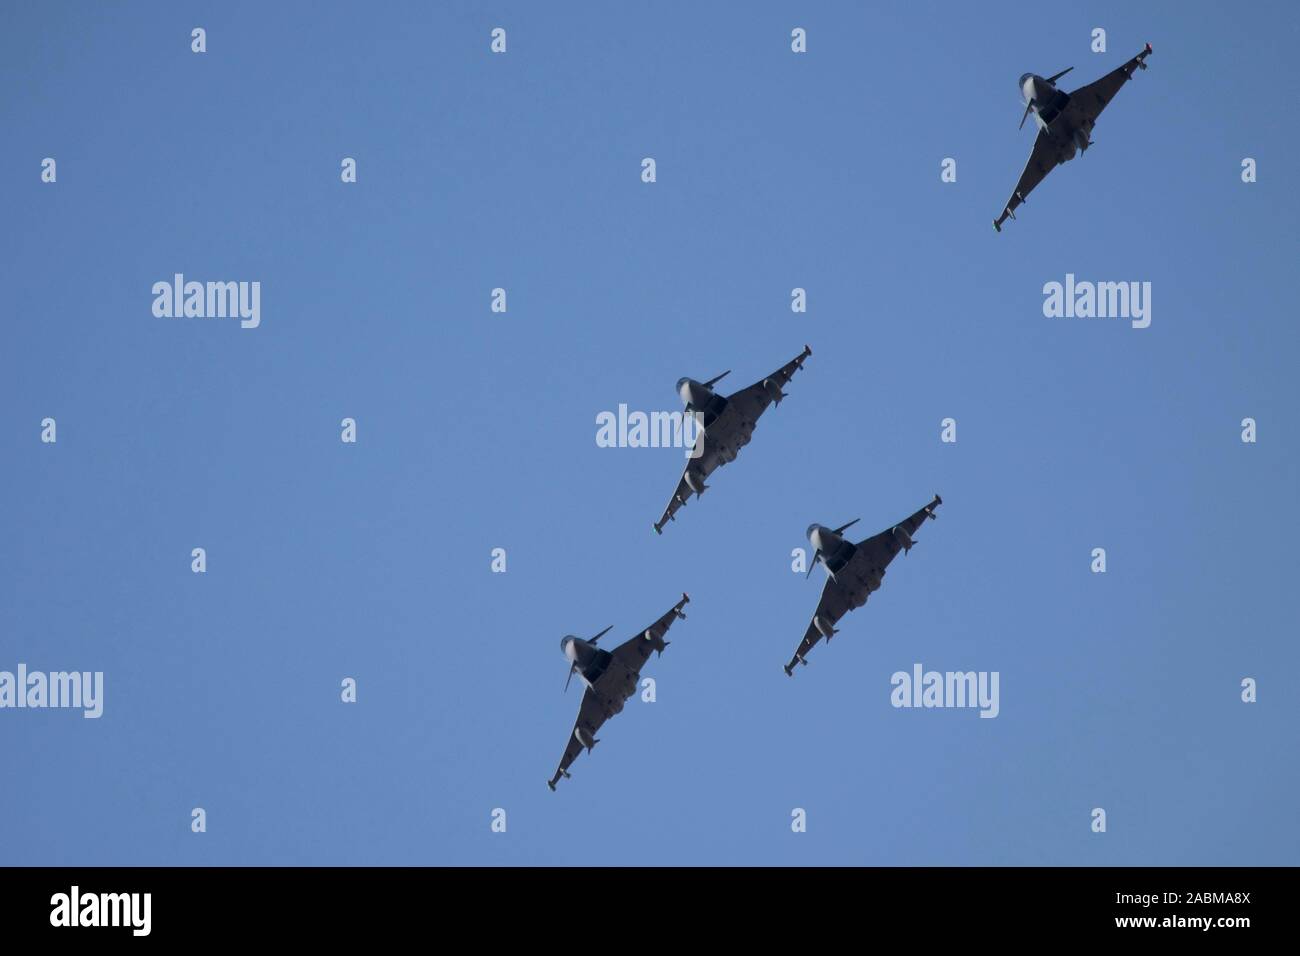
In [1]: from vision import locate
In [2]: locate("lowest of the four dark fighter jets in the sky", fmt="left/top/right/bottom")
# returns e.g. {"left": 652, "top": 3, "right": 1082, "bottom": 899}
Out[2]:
{"left": 546, "top": 593, "right": 690, "bottom": 790}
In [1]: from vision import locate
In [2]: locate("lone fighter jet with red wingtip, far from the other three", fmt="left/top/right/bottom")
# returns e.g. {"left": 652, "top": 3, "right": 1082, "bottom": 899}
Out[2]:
{"left": 993, "top": 43, "right": 1151, "bottom": 232}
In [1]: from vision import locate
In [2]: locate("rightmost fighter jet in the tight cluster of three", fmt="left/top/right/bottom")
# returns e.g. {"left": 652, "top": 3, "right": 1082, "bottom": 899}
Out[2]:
{"left": 785, "top": 494, "right": 944, "bottom": 676}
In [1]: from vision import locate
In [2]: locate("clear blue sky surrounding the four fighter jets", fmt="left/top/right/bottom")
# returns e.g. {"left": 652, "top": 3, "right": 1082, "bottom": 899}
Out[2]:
{"left": 0, "top": 3, "right": 1300, "bottom": 865}
